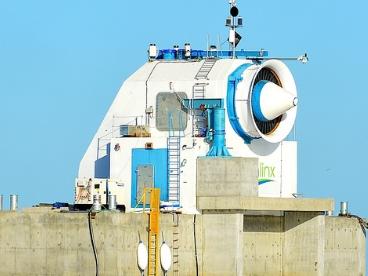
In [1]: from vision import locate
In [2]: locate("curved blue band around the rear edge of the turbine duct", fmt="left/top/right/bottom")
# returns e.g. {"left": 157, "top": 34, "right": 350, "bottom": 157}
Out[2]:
{"left": 226, "top": 63, "right": 253, "bottom": 144}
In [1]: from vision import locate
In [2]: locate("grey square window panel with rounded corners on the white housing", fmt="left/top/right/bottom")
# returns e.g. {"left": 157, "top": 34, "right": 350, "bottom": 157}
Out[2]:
{"left": 156, "top": 92, "right": 188, "bottom": 131}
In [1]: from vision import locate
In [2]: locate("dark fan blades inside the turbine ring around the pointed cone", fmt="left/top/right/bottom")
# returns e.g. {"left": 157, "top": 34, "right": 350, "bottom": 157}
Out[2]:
{"left": 254, "top": 67, "right": 282, "bottom": 135}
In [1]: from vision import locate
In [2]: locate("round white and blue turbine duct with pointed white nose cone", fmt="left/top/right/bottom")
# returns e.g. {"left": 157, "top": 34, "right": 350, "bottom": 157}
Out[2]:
{"left": 227, "top": 60, "right": 298, "bottom": 143}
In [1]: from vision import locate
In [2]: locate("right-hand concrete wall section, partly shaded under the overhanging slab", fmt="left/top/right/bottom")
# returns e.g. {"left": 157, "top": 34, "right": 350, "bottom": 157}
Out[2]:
{"left": 243, "top": 212, "right": 366, "bottom": 276}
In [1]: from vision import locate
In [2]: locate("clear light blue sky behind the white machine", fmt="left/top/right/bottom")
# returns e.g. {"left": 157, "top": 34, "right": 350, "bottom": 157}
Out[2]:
{"left": 0, "top": 0, "right": 368, "bottom": 220}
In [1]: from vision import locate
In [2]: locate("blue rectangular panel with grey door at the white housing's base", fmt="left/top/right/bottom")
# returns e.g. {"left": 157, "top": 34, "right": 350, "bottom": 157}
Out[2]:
{"left": 131, "top": 148, "right": 168, "bottom": 208}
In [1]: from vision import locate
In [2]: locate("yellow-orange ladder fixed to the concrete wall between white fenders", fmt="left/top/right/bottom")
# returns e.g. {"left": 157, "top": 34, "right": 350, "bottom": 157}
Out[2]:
{"left": 143, "top": 188, "right": 160, "bottom": 276}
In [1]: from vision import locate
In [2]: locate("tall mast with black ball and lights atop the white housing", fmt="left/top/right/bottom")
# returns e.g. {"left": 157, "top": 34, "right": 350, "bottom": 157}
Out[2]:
{"left": 225, "top": 0, "right": 243, "bottom": 59}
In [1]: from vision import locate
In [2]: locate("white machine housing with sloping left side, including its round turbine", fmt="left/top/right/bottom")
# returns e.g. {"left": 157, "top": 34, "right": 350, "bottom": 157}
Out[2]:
{"left": 75, "top": 58, "right": 297, "bottom": 213}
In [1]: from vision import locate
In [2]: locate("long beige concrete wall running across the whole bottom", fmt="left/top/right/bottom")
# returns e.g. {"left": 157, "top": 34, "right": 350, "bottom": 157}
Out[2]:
{"left": 0, "top": 208, "right": 365, "bottom": 276}
